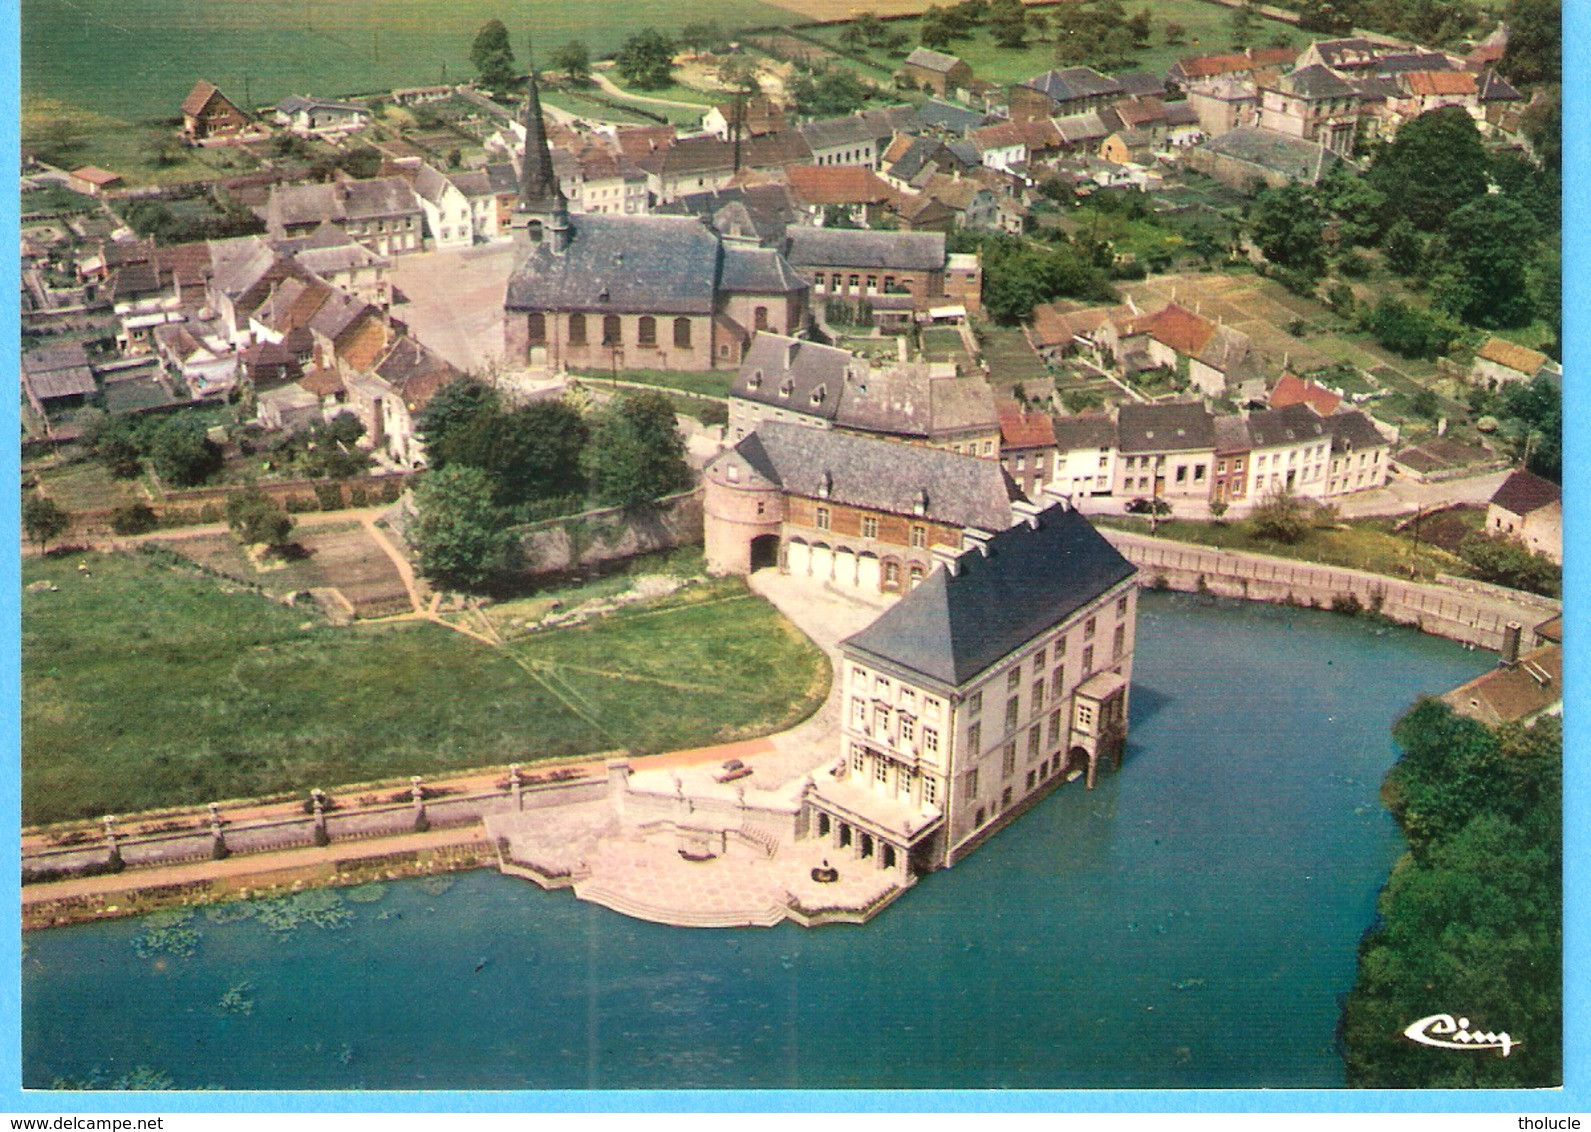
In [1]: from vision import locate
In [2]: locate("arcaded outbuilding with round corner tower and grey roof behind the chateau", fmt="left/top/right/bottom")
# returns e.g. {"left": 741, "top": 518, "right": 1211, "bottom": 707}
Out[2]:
{"left": 703, "top": 421, "right": 1015, "bottom": 593}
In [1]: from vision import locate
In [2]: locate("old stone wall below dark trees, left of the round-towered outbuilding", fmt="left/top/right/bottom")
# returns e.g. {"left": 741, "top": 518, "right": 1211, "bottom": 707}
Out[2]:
{"left": 515, "top": 488, "right": 702, "bottom": 576}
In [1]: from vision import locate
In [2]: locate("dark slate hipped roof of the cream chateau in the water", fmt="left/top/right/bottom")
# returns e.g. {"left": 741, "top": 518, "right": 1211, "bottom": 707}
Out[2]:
{"left": 842, "top": 504, "right": 1136, "bottom": 687}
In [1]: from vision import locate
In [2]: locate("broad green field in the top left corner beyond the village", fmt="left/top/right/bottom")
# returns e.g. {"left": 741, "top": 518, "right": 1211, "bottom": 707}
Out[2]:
{"left": 21, "top": 0, "right": 796, "bottom": 180}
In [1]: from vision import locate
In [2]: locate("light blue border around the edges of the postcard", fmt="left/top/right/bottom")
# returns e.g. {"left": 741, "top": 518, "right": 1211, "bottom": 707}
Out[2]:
{"left": 0, "top": 0, "right": 1591, "bottom": 1115}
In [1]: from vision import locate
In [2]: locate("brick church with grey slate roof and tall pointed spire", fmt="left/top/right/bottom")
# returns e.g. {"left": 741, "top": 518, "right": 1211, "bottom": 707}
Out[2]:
{"left": 503, "top": 76, "right": 807, "bottom": 370}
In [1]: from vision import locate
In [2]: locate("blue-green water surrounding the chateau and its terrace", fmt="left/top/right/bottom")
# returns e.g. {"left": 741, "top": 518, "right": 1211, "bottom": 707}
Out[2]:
{"left": 22, "top": 595, "right": 1492, "bottom": 1089}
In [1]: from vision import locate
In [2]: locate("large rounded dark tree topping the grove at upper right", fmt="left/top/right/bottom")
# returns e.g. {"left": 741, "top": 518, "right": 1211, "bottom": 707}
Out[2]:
{"left": 1367, "top": 107, "right": 1488, "bottom": 232}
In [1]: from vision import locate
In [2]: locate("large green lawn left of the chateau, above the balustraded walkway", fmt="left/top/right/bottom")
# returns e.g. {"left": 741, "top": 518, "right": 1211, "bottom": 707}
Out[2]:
{"left": 21, "top": 555, "right": 829, "bottom": 824}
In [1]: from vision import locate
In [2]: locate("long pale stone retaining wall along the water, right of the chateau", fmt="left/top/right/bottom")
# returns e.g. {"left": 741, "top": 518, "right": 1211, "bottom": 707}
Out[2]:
{"left": 1101, "top": 528, "right": 1561, "bottom": 649}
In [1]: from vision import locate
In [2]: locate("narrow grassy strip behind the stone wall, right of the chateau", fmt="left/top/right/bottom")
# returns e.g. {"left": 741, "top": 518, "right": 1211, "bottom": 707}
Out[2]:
{"left": 1095, "top": 515, "right": 1468, "bottom": 580}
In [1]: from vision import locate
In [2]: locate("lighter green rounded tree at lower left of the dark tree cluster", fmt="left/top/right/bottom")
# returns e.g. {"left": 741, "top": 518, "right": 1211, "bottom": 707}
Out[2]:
{"left": 406, "top": 467, "right": 519, "bottom": 591}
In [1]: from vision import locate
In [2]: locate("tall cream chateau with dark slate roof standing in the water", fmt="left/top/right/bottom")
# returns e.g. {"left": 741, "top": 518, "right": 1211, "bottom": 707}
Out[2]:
{"left": 833, "top": 489, "right": 1138, "bottom": 871}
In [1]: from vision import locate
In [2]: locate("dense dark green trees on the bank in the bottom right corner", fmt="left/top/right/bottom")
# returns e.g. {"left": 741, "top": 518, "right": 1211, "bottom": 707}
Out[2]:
{"left": 1341, "top": 700, "right": 1564, "bottom": 1089}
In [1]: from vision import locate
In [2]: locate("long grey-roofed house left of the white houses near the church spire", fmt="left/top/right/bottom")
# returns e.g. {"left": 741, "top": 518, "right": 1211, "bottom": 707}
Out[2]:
{"left": 256, "top": 176, "right": 425, "bottom": 256}
